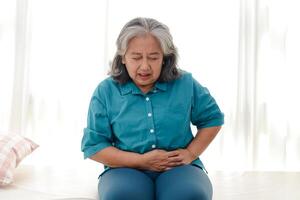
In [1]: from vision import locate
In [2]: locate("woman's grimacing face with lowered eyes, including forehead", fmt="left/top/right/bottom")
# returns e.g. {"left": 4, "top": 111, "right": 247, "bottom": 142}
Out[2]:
{"left": 122, "top": 34, "right": 163, "bottom": 93}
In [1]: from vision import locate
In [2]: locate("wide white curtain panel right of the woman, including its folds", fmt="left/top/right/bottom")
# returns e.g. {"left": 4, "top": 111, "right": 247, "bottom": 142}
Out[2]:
{"left": 233, "top": 0, "right": 300, "bottom": 170}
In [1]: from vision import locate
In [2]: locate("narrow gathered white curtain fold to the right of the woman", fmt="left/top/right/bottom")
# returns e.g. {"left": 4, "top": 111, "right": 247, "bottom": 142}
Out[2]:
{"left": 233, "top": 0, "right": 257, "bottom": 169}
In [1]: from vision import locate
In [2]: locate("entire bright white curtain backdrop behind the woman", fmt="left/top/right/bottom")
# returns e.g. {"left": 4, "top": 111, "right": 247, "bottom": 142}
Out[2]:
{"left": 0, "top": 0, "right": 300, "bottom": 170}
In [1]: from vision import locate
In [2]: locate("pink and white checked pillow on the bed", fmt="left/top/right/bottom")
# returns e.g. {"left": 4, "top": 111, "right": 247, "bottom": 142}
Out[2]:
{"left": 0, "top": 135, "right": 38, "bottom": 186}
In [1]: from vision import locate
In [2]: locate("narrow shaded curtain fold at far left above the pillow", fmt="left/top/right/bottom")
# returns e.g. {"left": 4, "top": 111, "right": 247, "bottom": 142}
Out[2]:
{"left": 9, "top": 0, "right": 30, "bottom": 134}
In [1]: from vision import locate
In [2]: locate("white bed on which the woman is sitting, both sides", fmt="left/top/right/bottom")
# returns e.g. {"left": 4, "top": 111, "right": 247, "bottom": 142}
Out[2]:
{"left": 0, "top": 165, "right": 300, "bottom": 200}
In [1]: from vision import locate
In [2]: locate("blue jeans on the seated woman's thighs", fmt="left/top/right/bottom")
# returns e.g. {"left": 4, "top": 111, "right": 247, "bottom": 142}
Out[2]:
{"left": 98, "top": 165, "right": 212, "bottom": 200}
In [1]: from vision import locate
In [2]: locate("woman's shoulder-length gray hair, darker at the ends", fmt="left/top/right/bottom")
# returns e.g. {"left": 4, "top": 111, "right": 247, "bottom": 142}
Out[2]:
{"left": 109, "top": 17, "right": 181, "bottom": 84}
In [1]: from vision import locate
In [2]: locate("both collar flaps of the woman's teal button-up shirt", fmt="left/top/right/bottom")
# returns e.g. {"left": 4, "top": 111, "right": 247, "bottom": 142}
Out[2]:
{"left": 120, "top": 81, "right": 168, "bottom": 96}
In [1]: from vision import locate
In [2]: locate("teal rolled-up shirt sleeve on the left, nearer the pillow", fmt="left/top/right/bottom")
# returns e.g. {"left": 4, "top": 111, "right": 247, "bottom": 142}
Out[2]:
{"left": 81, "top": 86, "right": 112, "bottom": 159}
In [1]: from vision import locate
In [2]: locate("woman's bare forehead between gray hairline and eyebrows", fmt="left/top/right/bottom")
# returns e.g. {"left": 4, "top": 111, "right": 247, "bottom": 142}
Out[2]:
{"left": 127, "top": 34, "right": 162, "bottom": 53}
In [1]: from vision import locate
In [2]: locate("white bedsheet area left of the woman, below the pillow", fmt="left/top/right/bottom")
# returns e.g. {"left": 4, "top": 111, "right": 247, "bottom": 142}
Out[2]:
{"left": 0, "top": 165, "right": 101, "bottom": 200}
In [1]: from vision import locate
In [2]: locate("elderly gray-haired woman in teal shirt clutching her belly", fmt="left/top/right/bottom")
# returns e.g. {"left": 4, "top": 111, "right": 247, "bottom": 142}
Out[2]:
{"left": 82, "top": 18, "right": 224, "bottom": 200}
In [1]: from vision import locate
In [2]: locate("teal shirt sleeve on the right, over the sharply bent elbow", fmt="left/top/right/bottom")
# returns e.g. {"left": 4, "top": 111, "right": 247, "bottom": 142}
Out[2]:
{"left": 191, "top": 79, "right": 224, "bottom": 129}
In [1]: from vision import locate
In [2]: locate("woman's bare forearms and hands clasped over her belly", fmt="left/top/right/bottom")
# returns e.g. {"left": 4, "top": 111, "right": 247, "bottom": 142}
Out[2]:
{"left": 90, "top": 126, "right": 221, "bottom": 171}
